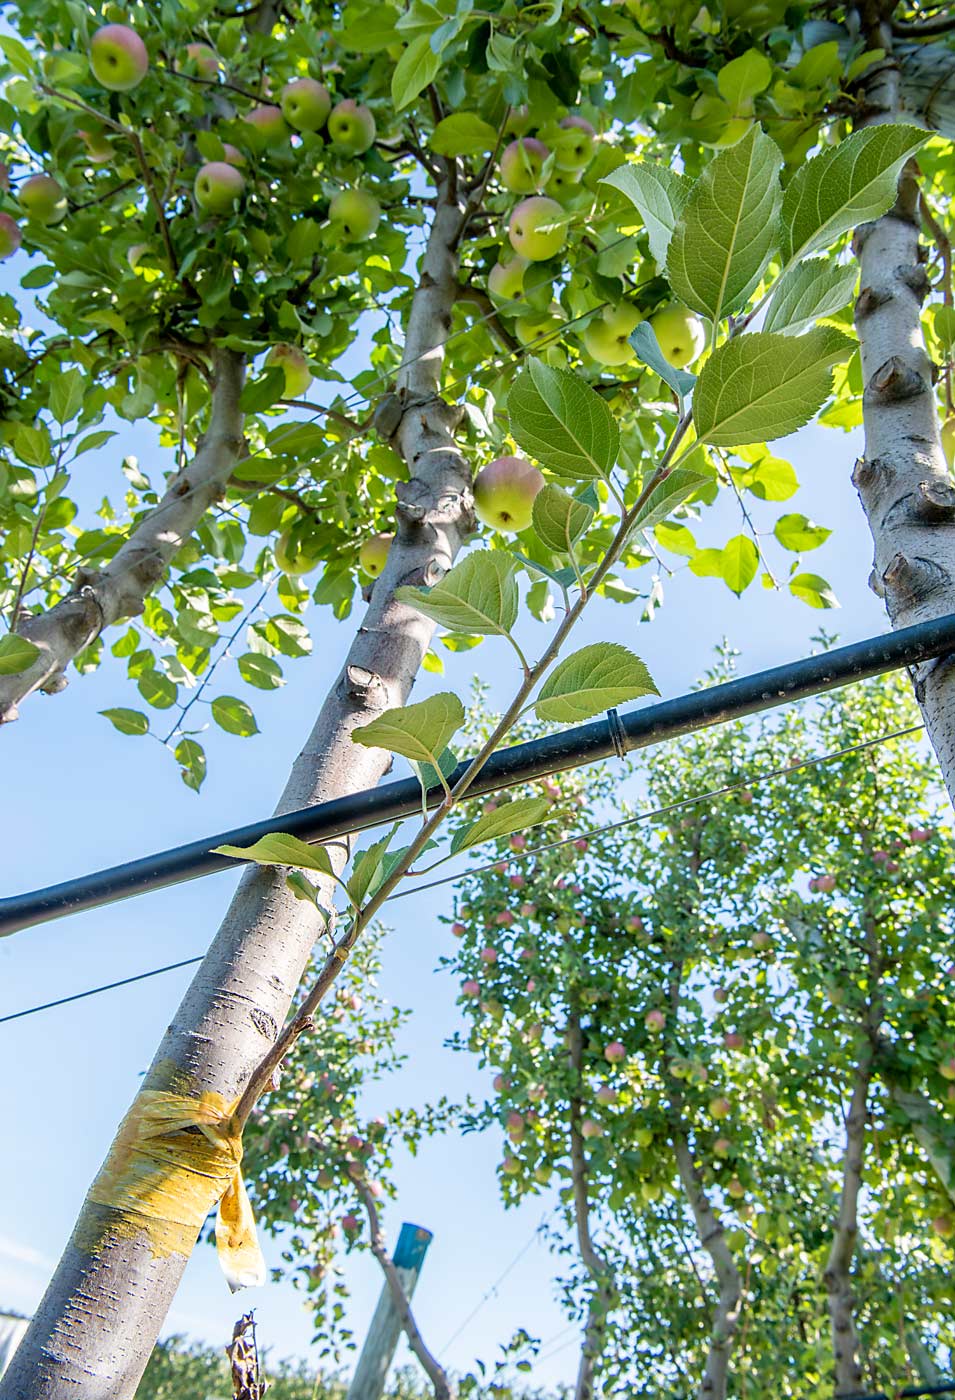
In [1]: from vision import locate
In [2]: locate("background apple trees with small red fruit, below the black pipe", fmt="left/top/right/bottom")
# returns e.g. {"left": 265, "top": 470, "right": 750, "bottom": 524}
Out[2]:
{"left": 447, "top": 666, "right": 955, "bottom": 1396}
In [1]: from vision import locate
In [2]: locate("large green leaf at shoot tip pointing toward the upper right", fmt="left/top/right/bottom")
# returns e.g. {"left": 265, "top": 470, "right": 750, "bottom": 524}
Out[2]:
{"left": 781, "top": 122, "right": 928, "bottom": 263}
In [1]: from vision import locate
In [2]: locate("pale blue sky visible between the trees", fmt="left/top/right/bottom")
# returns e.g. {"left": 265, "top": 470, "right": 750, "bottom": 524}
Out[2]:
{"left": 0, "top": 232, "right": 885, "bottom": 1383}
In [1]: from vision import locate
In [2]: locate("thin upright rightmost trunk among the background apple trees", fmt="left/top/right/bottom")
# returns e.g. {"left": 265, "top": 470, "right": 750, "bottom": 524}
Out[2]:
{"left": 823, "top": 1049, "right": 872, "bottom": 1396}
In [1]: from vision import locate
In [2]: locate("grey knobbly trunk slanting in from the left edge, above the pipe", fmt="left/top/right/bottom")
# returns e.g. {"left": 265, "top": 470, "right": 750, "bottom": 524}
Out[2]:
{"left": 0, "top": 349, "right": 245, "bottom": 724}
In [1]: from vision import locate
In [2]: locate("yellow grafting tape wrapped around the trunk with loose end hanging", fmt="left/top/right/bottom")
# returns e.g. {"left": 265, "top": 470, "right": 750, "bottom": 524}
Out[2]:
{"left": 90, "top": 1089, "right": 266, "bottom": 1291}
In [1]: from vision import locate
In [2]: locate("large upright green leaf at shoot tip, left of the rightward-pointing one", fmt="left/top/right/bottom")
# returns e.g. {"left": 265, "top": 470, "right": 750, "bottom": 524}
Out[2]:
{"left": 667, "top": 125, "right": 783, "bottom": 322}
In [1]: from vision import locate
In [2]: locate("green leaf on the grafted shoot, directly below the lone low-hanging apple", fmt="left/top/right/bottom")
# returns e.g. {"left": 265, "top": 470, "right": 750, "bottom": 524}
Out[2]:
{"left": 395, "top": 549, "right": 520, "bottom": 637}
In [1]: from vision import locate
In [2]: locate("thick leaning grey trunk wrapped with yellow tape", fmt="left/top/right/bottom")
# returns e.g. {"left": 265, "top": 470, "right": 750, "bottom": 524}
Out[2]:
{"left": 0, "top": 172, "right": 472, "bottom": 1400}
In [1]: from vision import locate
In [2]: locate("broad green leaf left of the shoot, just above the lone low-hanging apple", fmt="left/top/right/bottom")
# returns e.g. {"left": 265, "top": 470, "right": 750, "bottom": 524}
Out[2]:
{"left": 507, "top": 358, "right": 620, "bottom": 480}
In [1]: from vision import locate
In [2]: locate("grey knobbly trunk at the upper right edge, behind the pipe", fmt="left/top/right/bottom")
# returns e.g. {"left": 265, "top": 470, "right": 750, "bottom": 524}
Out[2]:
{"left": 853, "top": 13, "right": 955, "bottom": 801}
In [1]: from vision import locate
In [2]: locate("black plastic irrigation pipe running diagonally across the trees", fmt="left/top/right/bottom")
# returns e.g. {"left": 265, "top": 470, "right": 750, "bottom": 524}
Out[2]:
{"left": 0, "top": 615, "right": 955, "bottom": 937}
